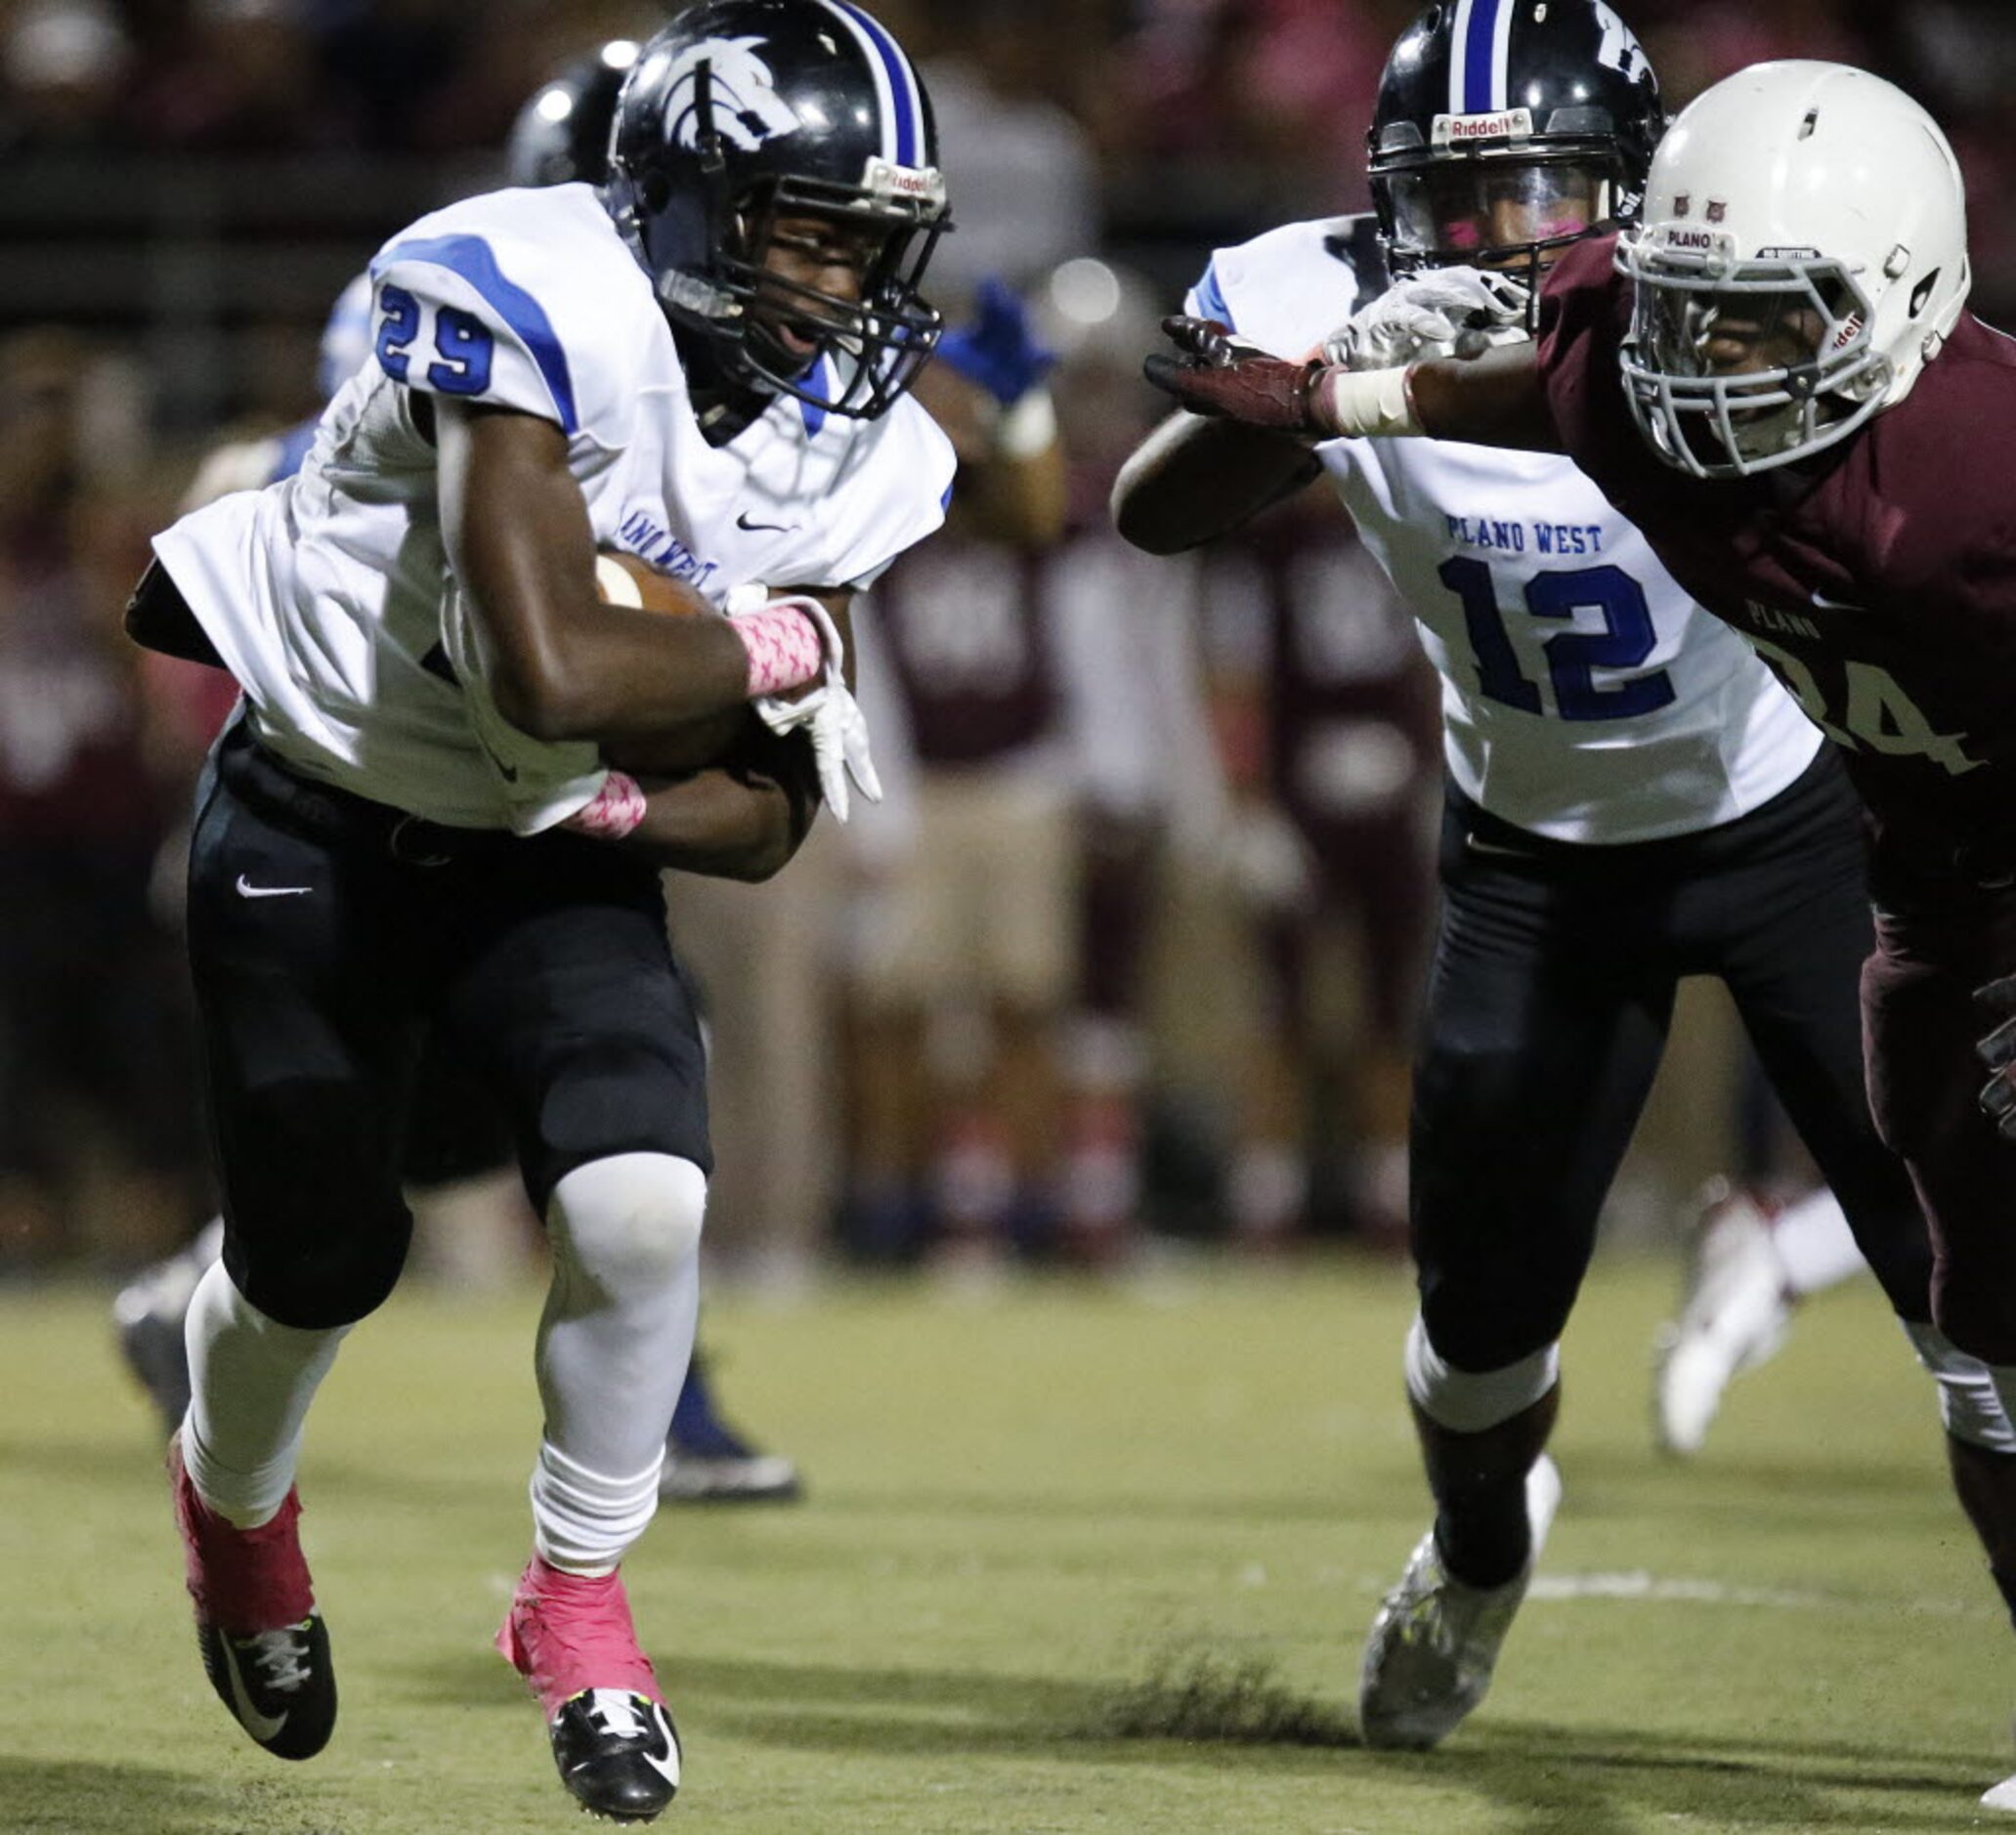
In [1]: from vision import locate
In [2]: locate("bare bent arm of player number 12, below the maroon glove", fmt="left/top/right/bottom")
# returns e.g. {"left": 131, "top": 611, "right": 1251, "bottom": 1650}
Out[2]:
{"left": 1113, "top": 413, "right": 1322, "bottom": 555}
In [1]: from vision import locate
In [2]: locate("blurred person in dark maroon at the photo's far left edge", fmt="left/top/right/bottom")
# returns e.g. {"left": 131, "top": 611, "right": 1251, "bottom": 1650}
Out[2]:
{"left": 0, "top": 333, "right": 199, "bottom": 1266}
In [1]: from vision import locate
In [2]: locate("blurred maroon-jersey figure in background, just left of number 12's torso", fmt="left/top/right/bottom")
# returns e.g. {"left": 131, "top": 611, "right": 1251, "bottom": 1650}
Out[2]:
{"left": 1206, "top": 486, "right": 1439, "bottom": 1248}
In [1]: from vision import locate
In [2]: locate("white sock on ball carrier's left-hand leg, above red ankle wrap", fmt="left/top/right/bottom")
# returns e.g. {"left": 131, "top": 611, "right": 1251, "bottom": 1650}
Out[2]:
{"left": 182, "top": 1262, "right": 351, "bottom": 1528}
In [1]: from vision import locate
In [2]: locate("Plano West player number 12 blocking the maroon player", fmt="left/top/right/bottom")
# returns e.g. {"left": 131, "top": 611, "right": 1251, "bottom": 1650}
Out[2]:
{"left": 1115, "top": 0, "right": 1959, "bottom": 1746}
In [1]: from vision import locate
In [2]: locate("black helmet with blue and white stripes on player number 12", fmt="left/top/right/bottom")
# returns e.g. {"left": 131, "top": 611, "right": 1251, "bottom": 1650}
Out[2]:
{"left": 1369, "top": 0, "right": 1665, "bottom": 282}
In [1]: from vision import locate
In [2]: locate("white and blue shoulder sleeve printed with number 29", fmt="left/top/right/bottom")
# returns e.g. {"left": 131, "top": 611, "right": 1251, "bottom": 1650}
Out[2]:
{"left": 371, "top": 234, "right": 580, "bottom": 438}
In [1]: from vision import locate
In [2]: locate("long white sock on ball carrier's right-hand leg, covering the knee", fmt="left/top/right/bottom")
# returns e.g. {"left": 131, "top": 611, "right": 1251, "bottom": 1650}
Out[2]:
{"left": 533, "top": 1153, "right": 708, "bottom": 1573}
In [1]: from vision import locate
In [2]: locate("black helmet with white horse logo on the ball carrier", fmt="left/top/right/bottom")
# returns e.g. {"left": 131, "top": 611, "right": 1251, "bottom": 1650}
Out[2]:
{"left": 605, "top": 0, "right": 952, "bottom": 419}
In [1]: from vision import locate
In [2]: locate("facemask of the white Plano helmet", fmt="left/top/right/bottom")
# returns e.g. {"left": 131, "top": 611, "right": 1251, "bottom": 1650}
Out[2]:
{"left": 1617, "top": 235, "right": 1895, "bottom": 478}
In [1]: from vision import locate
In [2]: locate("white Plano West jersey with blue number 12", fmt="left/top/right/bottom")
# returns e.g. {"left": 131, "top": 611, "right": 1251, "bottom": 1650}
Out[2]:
{"left": 1187, "top": 218, "right": 1821, "bottom": 843}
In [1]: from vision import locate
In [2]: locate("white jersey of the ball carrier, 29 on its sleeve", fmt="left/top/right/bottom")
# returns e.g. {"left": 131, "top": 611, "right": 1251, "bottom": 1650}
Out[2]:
{"left": 155, "top": 186, "right": 954, "bottom": 832}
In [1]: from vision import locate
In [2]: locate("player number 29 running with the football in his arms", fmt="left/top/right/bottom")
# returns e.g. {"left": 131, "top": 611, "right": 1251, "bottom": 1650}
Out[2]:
{"left": 129, "top": 0, "right": 952, "bottom": 1821}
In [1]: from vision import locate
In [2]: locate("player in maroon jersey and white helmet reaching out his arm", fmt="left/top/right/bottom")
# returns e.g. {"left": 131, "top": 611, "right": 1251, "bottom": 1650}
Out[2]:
{"left": 1149, "top": 63, "right": 2016, "bottom": 1809}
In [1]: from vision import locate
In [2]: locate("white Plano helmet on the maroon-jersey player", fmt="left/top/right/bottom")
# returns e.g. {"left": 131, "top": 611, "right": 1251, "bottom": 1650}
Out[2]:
{"left": 1617, "top": 61, "right": 1972, "bottom": 478}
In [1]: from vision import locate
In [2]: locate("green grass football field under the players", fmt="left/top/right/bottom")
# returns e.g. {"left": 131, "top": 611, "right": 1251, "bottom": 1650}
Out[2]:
{"left": 0, "top": 1264, "right": 2016, "bottom": 1835}
